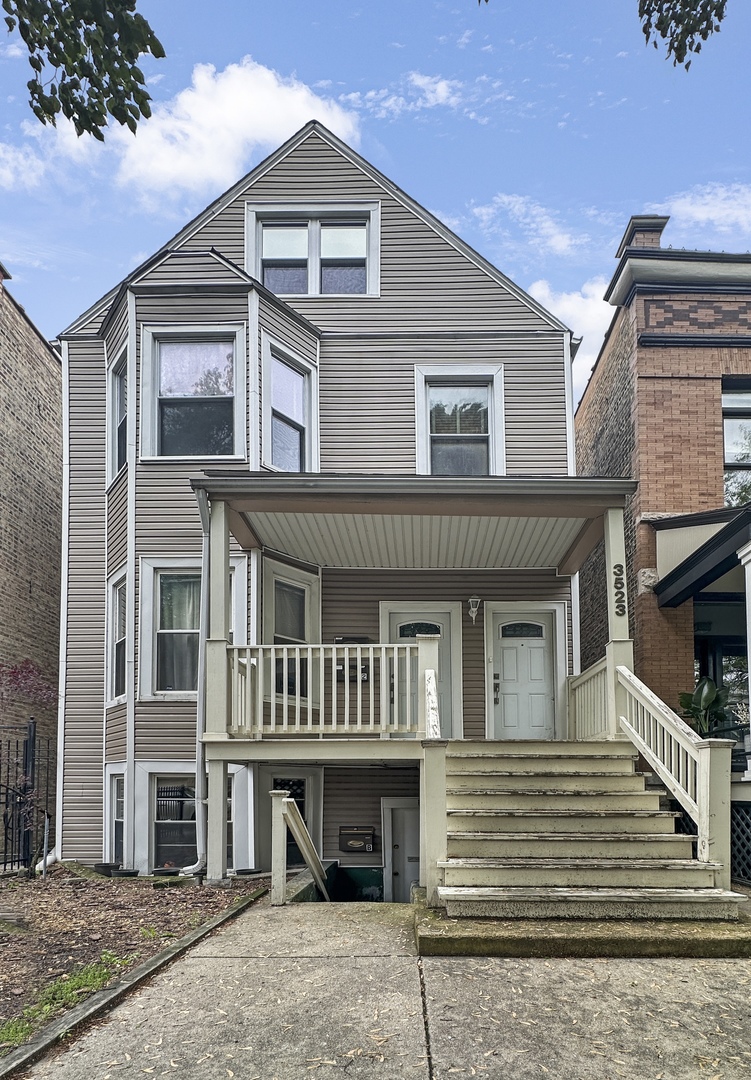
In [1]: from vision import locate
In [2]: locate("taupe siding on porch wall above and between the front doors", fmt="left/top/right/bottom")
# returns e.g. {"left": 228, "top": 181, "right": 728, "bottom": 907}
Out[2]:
{"left": 321, "top": 569, "right": 572, "bottom": 739}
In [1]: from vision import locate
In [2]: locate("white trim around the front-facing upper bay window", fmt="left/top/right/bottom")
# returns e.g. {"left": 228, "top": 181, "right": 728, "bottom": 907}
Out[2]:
{"left": 140, "top": 323, "right": 247, "bottom": 461}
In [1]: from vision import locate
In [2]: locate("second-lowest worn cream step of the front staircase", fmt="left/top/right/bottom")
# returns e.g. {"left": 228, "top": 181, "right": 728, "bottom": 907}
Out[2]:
{"left": 439, "top": 859, "right": 722, "bottom": 889}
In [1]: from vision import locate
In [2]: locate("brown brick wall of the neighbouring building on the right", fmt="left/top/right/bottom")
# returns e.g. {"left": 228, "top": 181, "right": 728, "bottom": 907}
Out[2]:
{"left": 576, "top": 282, "right": 751, "bottom": 708}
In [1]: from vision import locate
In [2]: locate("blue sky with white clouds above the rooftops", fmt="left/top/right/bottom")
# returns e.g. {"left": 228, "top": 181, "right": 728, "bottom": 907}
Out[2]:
{"left": 0, "top": 0, "right": 751, "bottom": 399}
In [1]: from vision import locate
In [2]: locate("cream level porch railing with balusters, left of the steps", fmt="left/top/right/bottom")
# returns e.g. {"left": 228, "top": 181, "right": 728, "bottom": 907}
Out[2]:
{"left": 227, "top": 636, "right": 428, "bottom": 739}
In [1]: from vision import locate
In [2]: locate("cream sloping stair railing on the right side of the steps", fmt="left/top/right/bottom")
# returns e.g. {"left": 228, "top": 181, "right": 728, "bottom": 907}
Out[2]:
{"left": 616, "top": 666, "right": 733, "bottom": 889}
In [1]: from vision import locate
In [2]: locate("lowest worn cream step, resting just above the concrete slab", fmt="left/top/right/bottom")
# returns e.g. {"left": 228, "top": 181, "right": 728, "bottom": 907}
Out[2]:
{"left": 438, "top": 886, "right": 746, "bottom": 919}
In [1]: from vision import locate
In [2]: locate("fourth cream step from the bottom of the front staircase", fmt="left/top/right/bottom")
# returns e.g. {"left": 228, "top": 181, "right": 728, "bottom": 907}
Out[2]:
{"left": 446, "top": 808, "right": 680, "bottom": 836}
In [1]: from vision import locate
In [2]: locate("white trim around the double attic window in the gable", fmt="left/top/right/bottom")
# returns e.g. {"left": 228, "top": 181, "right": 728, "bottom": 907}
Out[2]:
{"left": 245, "top": 199, "right": 380, "bottom": 300}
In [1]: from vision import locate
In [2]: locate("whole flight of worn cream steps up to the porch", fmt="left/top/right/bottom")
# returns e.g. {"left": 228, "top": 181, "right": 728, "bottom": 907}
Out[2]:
{"left": 439, "top": 741, "right": 745, "bottom": 919}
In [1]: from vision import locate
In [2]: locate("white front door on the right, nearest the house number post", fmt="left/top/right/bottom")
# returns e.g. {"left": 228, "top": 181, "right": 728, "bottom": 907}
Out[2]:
{"left": 488, "top": 611, "right": 555, "bottom": 739}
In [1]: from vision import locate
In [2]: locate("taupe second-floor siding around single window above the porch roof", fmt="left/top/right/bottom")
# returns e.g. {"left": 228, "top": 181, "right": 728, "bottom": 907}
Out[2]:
{"left": 320, "top": 334, "right": 568, "bottom": 475}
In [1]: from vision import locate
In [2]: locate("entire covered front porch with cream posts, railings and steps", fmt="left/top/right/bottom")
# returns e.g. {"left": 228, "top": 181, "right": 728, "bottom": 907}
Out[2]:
{"left": 193, "top": 476, "right": 735, "bottom": 917}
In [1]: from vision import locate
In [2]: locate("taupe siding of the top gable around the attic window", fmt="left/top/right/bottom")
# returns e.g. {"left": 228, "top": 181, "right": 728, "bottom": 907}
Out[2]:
{"left": 185, "top": 134, "right": 561, "bottom": 330}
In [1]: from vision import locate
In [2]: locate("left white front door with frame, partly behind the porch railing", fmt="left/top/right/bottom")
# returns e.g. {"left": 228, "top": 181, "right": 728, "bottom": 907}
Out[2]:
{"left": 381, "top": 602, "right": 461, "bottom": 739}
